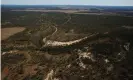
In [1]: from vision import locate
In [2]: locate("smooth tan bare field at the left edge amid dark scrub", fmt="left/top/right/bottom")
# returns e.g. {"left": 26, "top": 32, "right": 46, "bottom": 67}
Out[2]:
{"left": 1, "top": 27, "right": 26, "bottom": 40}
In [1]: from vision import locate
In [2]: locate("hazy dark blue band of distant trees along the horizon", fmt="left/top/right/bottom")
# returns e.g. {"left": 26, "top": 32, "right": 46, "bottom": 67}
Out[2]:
{"left": 1, "top": 5, "right": 133, "bottom": 11}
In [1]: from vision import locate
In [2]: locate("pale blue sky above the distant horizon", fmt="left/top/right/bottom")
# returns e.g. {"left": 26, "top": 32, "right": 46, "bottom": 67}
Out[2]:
{"left": 1, "top": 0, "right": 133, "bottom": 6}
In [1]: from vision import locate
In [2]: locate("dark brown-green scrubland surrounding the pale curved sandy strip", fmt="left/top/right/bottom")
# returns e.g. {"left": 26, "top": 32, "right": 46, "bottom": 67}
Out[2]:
{"left": 1, "top": 6, "right": 133, "bottom": 80}
